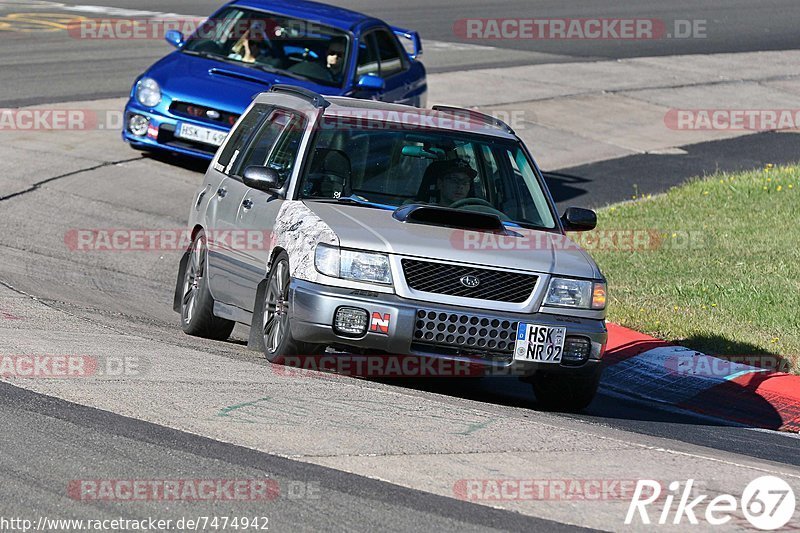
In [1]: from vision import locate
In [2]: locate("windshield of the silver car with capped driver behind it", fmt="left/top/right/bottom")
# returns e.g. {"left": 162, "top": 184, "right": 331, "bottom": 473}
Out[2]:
{"left": 301, "top": 117, "right": 555, "bottom": 229}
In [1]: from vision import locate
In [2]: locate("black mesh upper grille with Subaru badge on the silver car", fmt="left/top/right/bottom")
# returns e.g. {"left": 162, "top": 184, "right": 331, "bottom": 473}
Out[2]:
{"left": 402, "top": 259, "right": 538, "bottom": 303}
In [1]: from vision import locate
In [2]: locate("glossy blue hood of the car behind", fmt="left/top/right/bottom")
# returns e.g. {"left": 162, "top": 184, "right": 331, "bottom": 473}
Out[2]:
{"left": 145, "top": 51, "right": 341, "bottom": 113}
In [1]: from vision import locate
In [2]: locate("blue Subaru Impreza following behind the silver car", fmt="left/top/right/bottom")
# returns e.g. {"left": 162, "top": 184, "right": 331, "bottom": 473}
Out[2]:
{"left": 122, "top": 0, "right": 428, "bottom": 159}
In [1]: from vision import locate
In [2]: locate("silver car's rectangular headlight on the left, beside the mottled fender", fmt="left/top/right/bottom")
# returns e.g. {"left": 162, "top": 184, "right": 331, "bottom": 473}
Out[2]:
{"left": 314, "top": 244, "right": 392, "bottom": 285}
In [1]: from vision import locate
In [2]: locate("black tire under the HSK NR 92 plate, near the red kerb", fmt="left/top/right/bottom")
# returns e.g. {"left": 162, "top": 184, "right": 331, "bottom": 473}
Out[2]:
{"left": 530, "top": 372, "right": 600, "bottom": 412}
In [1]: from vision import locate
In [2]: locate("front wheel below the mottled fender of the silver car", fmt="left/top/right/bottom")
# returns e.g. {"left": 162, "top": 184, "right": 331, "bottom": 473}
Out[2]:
{"left": 258, "top": 251, "right": 324, "bottom": 365}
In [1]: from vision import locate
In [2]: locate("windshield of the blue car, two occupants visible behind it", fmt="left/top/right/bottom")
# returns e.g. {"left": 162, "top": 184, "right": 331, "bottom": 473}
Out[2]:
{"left": 188, "top": 8, "right": 349, "bottom": 87}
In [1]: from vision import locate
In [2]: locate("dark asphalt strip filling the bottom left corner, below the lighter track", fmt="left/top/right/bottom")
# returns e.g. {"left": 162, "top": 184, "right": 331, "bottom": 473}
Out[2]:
{"left": 0, "top": 383, "right": 583, "bottom": 532}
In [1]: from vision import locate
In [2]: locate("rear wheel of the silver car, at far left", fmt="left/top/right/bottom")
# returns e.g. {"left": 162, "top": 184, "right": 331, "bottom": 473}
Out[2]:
{"left": 181, "top": 231, "right": 236, "bottom": 341}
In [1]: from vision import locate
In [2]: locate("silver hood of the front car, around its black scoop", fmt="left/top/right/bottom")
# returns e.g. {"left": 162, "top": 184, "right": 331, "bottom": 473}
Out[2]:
{"left": 305, "top": 201, "right": 602, "bottom": 279}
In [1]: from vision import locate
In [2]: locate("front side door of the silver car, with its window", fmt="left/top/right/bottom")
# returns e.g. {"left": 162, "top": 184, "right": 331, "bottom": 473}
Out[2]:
{"left": 230, "top": 108, "right": 306, "bottom": 311}
